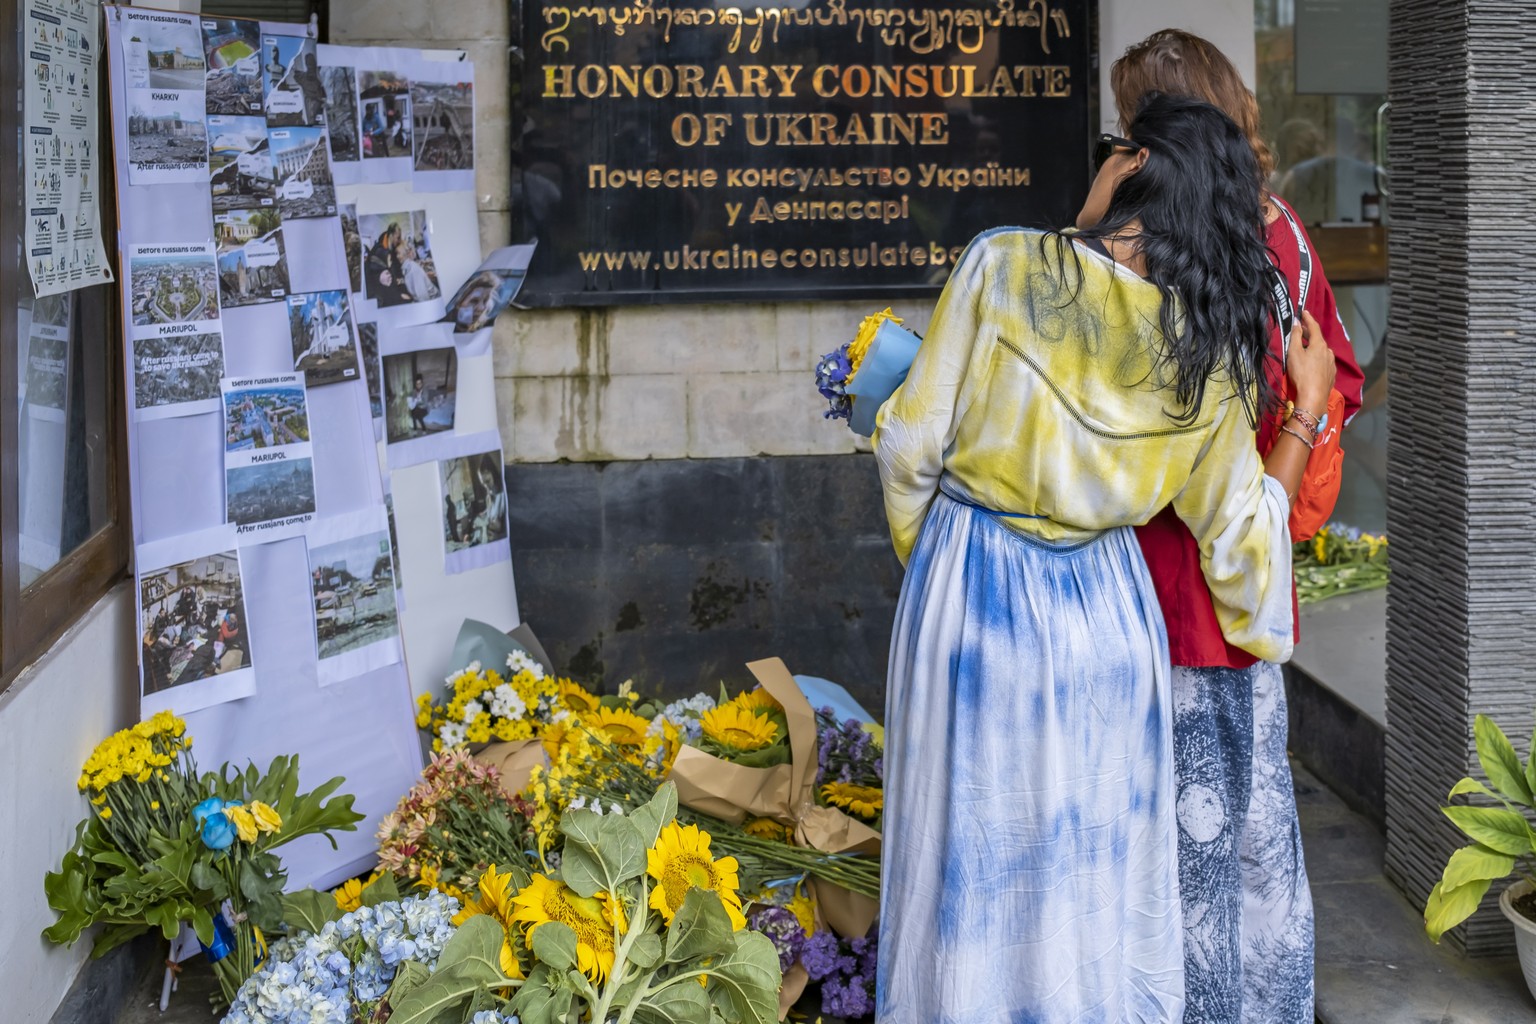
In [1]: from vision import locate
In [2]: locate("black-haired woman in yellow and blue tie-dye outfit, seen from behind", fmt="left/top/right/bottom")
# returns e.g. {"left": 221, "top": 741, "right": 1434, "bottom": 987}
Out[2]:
{"left": 874, "top": 97, "right": 1333, "bottom": 1024}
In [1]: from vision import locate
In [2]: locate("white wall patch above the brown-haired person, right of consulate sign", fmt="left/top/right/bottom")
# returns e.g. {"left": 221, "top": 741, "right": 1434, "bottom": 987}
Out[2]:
{"left": 1098, "top": 0, "right": 1256, "bottom": 132}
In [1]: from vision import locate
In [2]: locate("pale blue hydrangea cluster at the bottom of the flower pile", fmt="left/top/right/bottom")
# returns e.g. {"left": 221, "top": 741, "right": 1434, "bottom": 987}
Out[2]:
{"left": 224, "top": 892, "right": 460, "bottom": 1024}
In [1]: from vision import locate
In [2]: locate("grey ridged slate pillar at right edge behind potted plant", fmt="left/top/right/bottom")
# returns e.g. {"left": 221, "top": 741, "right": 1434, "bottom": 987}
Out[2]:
{"left": 1385, "top": 0, "right": 1536, "bottom": 955}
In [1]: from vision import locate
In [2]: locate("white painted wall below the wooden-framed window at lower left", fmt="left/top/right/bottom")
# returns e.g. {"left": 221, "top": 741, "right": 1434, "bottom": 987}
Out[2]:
{"left": 0, "top": 583, "right": 138, "bottom": 1024}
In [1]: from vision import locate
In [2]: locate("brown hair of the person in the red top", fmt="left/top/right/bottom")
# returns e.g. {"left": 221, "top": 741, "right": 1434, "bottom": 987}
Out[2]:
{"left": 1109, "top": 29, "right": 1275, "bottom": 181}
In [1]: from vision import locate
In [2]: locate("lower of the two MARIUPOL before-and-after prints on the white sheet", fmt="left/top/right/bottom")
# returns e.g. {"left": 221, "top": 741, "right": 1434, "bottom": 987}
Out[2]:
{"left": 223, "top": 373, "right": 315, "bottom": 543}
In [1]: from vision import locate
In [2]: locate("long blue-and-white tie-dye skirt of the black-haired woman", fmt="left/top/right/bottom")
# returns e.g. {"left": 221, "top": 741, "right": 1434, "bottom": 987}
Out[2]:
{"left": 877, "top": 494, "right": 1184, "bottom": 1024}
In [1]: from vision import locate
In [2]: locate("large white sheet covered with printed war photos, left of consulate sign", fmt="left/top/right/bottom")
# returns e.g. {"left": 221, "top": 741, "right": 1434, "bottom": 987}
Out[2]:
{"left": 103, "top": 6, "right": 503, "bottom": 883}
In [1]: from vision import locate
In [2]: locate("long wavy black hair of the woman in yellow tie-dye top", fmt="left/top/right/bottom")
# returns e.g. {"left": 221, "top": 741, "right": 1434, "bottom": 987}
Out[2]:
{"left": 1064, "top": 92, "right": 1278, "bottom": 425}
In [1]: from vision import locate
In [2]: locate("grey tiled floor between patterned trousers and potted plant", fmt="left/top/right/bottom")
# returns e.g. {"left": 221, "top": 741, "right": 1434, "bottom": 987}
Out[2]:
{"left": 1296, "top": 768, "right": 1536, "bottom": 1024}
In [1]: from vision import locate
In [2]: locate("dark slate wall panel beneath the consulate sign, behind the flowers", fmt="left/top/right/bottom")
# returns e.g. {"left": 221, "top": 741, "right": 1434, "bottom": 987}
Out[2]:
{"left": 507, "top": 454, "right": 902, "bottom": 715}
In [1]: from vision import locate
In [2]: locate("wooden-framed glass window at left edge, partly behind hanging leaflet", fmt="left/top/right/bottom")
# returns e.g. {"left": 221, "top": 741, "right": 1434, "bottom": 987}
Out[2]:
{"left": 0, "top": 3, "right": 129, "bottom": 691}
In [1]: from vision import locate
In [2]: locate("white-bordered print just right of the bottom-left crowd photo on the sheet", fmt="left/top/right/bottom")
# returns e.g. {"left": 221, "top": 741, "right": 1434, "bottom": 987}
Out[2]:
{"left": 309, "top": 505, "right": 401, "bottom": 686}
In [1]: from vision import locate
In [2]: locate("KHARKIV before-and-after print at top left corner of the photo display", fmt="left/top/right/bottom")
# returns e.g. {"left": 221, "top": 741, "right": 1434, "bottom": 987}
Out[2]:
{"left": 123, "top": 8, "right": 207, "bottom": 184}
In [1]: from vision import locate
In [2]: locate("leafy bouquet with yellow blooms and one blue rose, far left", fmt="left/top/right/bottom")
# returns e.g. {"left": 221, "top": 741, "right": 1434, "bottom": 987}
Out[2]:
{"left": 43, "top": 711, "right": 362, "bottom": 1003}
